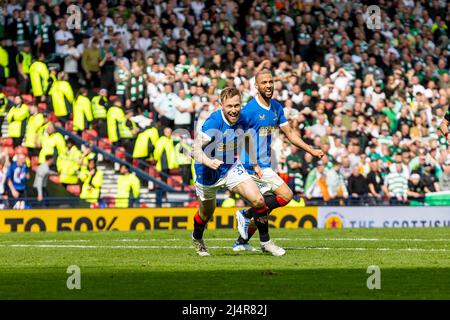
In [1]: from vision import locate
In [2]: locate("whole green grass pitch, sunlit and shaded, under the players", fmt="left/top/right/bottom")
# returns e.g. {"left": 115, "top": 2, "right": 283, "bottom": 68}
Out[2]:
{"left": 0, "top": 228, "right": 450, "bottom": 299}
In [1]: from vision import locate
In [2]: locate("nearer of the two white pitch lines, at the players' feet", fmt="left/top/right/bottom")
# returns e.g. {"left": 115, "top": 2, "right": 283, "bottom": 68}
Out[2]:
{"left": 0, "top": 244, "right": 450, "bottom": 252}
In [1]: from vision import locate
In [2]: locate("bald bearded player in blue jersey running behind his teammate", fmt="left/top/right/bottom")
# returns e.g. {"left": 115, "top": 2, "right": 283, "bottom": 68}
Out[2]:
{"left": 233, "top": 69, "right": 323, "bottom": 251}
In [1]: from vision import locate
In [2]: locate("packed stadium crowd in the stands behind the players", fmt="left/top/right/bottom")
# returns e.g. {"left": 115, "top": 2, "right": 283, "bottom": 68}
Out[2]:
{"left": 0, "top": 0, "right": 450, "bottom": 208}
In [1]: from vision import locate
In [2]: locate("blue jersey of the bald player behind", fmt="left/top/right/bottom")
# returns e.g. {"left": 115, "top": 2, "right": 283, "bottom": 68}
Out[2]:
{"left": 241, "top": 97, "right": 288, "bottom": 173}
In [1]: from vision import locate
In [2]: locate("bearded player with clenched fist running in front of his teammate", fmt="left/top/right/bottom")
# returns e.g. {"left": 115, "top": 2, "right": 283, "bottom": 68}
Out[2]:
{"left": 192, "top": 87, "right": 280, "bottom": 256}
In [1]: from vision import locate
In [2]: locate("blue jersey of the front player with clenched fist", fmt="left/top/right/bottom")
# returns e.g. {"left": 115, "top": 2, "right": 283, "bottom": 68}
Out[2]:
{"left": 194, "top": 110, "right": 248, "bottom": 186}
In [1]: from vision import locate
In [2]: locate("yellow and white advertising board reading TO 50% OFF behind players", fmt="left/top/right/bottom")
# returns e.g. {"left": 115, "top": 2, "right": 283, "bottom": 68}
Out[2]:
{"left": 0, "top": 207, "right": 450, "bottom": 233}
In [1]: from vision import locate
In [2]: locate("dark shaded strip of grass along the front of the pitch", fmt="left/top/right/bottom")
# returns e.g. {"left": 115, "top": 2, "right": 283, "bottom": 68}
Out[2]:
{"left": 0, "top": 268, "right": 450, "bottom": 300}
